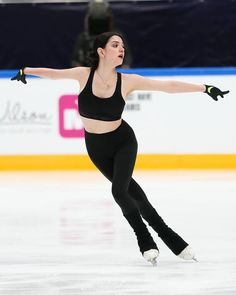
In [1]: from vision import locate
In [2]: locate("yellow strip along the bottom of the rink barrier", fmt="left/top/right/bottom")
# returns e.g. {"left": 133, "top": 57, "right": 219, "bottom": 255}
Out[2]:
{"left": 0, "top": 154, "right": 236, "bottom": 170}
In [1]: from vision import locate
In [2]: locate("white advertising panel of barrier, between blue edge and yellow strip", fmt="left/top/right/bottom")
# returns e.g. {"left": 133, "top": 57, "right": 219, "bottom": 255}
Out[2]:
{"left": 0, "top": 70, "right": 236, "bottom": 155}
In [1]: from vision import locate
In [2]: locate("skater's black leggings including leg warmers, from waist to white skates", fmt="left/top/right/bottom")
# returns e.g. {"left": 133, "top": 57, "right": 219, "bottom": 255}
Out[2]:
{"left": 85, "top": 120, "right": 188, "bottom": 254}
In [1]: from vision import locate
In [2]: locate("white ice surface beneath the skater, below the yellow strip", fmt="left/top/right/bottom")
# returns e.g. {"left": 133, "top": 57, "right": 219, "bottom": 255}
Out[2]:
{"left": 0, "top": 171, "right": 236, "bottom": 295}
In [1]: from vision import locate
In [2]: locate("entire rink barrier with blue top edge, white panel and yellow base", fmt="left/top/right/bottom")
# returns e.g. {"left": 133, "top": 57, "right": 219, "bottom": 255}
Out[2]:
{"left": 0, "top": 68, "right": 236, "bottom": 170}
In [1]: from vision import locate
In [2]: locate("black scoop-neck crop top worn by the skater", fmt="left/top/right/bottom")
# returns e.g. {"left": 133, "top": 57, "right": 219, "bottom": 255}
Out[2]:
{"left": 78, "top": 69, "right": 125, "bottom": 121}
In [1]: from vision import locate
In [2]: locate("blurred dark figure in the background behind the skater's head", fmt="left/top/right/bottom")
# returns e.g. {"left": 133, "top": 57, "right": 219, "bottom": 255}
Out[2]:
{"left": 71, "top": 0, "right": 132, "bottom": 69}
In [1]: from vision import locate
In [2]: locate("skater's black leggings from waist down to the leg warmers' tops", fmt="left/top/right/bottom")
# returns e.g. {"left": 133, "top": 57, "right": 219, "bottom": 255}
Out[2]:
{"left": 85, "top": 120, "right": 153, "bottom": 216}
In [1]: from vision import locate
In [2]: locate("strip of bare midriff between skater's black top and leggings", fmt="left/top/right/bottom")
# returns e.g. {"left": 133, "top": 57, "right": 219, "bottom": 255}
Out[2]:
{"left": 80, "top": 116, "right": 122, "bottom": 134}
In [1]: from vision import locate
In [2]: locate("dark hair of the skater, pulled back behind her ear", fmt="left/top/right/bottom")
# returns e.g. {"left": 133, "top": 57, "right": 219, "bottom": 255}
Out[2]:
{"left": 90, "top": 32, "right": 123, "bottom": 70}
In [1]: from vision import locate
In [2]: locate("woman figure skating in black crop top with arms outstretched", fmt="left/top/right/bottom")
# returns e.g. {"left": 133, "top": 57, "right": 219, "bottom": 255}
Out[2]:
{"left": 12, "top": 32, "right": 228, "bottom": 264}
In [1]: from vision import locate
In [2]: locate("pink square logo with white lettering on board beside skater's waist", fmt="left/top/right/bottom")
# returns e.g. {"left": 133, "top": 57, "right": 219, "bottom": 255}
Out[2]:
{"left": 59, "top": 94, "right": 84, "bottom": 138}
